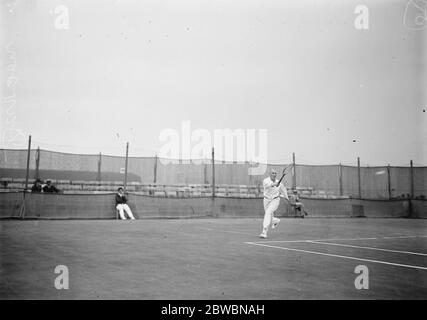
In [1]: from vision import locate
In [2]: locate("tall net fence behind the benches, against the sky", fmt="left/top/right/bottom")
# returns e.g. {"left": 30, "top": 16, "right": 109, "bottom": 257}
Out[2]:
{"left": 0, "top": 149, "right": 427, "bottom": 199}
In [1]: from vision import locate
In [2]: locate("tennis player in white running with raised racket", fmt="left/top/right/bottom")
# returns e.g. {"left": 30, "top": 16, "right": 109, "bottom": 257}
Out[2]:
{"left": 259, "top": 169, "right": 289, "bottom": 238}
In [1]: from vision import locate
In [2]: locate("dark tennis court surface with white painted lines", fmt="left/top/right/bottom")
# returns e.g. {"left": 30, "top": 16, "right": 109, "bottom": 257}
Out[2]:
{"left": 0, "top": 218, "right": 427, "bottom": 300}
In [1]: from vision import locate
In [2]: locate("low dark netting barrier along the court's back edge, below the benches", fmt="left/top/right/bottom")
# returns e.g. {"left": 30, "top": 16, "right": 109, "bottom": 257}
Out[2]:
{"left": 0, "top": 192, "right": 427, "bottom": 219}
